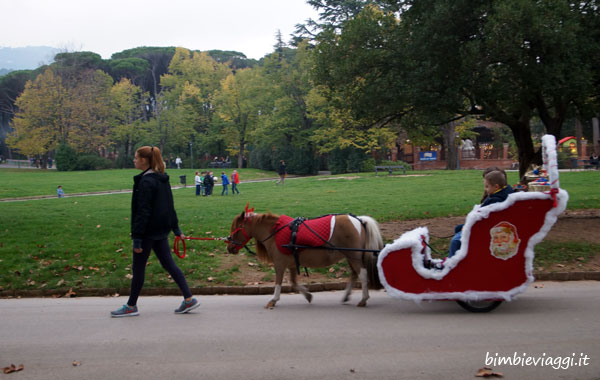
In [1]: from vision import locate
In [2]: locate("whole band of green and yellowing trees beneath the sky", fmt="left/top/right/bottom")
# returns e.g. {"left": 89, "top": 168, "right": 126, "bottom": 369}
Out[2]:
{"left": 0, "top": 0, "right": 600, "bottom": 173}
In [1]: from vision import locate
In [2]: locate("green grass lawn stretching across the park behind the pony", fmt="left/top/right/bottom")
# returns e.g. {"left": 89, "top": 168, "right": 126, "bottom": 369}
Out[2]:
{"left": 0, "top": 170, "right": 600, "bottom": 289}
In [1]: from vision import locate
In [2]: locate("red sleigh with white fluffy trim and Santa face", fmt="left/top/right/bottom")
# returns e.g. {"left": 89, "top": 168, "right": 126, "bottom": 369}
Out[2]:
{"left": 377, "top": 135, "right": 569, "bottom": 312}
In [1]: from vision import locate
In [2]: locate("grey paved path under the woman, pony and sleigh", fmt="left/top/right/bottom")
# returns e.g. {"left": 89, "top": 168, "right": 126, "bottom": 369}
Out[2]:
{"left": 0, "top": 281, "right": 600, "bottom": 380}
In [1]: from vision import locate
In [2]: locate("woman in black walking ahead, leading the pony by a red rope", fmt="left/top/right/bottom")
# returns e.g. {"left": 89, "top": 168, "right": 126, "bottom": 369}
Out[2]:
{"left": 111, "top": 146, "right": 200, "bottom": 317}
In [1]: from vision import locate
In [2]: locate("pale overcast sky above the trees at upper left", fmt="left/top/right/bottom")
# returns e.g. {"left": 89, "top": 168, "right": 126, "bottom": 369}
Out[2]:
{"left": 0, "top": 0, "right": 317, "bottom": 59}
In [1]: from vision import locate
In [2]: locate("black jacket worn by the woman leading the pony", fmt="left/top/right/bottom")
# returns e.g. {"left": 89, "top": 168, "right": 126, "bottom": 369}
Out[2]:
{"left": 131, "top": 170, "right": 181, "bottom": 248}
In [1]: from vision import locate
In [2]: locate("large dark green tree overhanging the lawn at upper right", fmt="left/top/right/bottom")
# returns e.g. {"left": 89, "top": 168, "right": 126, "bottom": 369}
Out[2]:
{"left": 316, "top": 0, "right": 600, "bottom": 173}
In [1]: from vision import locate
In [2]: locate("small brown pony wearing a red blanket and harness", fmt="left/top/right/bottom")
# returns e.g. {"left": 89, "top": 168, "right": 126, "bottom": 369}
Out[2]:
{"left": 227, "top": 206, "right": 383, "bottom": 308}
